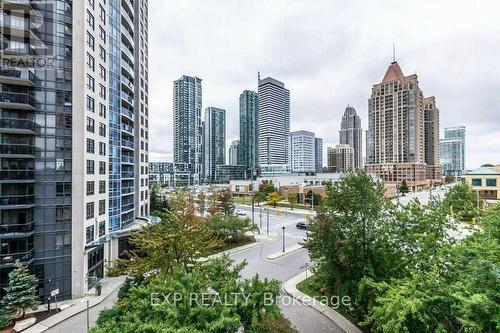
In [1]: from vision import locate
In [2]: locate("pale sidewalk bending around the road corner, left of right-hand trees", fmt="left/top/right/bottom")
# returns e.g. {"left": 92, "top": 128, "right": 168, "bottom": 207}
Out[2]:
{"left": 281, "top": 271, "right": 363, "bottom": 333}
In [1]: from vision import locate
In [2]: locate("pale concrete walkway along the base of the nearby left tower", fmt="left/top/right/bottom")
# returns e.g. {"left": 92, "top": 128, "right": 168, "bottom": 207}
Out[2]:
{"left": 23, "top": 276, "right": 126, "bottom": 333}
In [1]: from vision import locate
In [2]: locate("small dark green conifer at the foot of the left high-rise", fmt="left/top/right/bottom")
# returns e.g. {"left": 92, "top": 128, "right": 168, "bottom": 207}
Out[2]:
{"left": 2, "top": 261, "right": 40, "bottom": 318}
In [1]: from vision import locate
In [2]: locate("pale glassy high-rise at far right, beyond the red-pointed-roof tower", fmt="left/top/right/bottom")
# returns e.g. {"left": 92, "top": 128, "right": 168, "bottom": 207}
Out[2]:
{"left": 440, "top": 126, "right": 465, "bottom": 176}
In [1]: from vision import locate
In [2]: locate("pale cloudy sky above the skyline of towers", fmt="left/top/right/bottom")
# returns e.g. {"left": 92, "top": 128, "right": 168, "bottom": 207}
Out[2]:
{"left": 149, "top": 0, "right": 500, "bottom": 168}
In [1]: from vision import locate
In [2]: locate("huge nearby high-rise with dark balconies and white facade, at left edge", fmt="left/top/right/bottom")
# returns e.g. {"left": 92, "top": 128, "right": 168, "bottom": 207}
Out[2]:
{"left": 0, "top": 0, "right": 149, "bottom": 301}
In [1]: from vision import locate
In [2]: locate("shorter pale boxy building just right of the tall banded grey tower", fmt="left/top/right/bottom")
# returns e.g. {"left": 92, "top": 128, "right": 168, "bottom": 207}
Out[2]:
{"left": 290, "top": 131, "right": 316, "bottom": 173}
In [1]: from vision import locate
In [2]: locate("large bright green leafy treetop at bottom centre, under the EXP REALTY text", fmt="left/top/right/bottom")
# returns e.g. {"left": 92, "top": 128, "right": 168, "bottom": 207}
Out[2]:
{"left": 90, "top": 256, "right": 293, "bottom": 333}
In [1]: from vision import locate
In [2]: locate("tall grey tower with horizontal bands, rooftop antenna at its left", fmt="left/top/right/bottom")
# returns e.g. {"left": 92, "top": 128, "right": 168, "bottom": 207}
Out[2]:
{"left": 257, "top": 77, "right": 290, "bottom": 172}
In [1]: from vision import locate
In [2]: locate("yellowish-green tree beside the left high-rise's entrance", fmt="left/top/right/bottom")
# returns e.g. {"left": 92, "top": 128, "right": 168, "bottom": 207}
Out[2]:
{"left": 117, "top": 202, "right": 222, "bottom": 279}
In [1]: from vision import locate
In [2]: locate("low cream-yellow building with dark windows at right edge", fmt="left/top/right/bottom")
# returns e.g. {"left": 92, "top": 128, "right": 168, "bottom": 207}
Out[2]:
{"left": 464, "top": 165, "right": 500, "bottom": 201}
